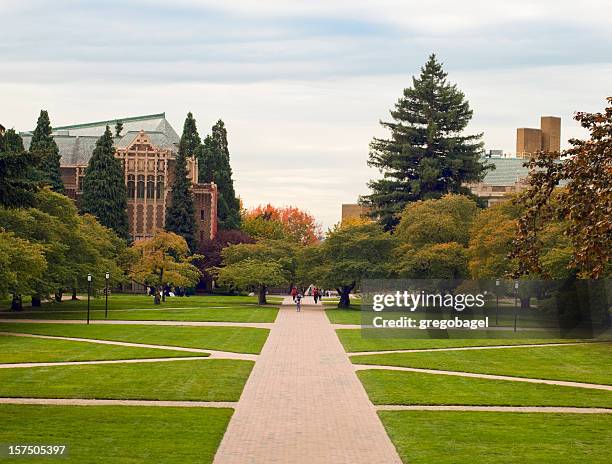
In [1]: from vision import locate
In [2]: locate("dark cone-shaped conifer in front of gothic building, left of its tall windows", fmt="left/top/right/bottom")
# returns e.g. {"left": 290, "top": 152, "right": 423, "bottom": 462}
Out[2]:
{"left": 81, "top": 126, "right": 129, "bottom": 240}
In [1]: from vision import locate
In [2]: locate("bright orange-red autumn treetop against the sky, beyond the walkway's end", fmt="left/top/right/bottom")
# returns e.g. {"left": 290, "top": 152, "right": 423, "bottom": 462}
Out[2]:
{"left": 244, "top": 203, "right": 321, "bottom": 245}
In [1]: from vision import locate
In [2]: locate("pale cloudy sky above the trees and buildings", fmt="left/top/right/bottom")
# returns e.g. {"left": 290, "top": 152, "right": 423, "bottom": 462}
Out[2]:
{"left": 0, "top": 0, "right": 612, "bottom": 226}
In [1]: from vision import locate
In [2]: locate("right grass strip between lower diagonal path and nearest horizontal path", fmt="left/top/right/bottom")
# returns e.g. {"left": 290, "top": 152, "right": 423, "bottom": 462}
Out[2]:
{"left": 357, "top": 370, "right": 612, "bottom": 408}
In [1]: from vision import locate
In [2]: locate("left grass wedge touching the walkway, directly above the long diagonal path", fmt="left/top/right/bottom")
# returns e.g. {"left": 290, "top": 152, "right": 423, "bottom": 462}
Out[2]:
{"left": 0, "top": 323, "right": 270, "bottom": 354}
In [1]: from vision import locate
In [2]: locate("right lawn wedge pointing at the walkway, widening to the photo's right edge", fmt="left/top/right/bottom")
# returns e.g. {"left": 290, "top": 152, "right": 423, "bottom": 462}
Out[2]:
{"left": 351, "top": 343, "right": 612, "bottom": 385}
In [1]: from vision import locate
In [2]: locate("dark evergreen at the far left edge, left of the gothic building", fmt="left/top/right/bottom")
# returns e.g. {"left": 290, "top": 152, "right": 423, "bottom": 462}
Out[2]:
{"left": 0, "top": 129, "right": 39, "bottom": 208}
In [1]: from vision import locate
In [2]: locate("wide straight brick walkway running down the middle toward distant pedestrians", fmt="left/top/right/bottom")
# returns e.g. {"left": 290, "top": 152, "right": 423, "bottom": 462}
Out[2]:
{"left": 215, "top": 298, "right": 401, "bottom": 464}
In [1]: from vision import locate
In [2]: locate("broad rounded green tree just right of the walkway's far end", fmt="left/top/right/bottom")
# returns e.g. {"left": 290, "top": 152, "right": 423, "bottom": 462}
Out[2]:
{"left": 306, "top": 223, "right": 396, "bottom": 308}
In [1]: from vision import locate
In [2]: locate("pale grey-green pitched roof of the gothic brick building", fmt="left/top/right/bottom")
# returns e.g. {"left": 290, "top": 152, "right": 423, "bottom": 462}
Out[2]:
{"left": 21, "top": 113, "right": 180, "bottom": 166}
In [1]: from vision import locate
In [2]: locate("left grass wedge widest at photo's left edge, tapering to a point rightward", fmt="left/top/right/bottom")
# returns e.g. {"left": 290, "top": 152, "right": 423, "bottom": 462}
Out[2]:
{"left": 0, "top": 335, "right": 206, "bottom": 364}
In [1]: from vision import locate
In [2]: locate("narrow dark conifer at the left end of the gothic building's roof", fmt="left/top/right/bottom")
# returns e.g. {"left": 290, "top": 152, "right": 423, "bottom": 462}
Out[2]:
{"left": 30, "top": 110, "right": 64, "bottom": 193}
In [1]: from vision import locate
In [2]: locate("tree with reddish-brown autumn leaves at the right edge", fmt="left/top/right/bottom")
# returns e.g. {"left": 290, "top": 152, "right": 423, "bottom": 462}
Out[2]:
{"left": 511, "top": 97, "right": 612, "bottom": 279}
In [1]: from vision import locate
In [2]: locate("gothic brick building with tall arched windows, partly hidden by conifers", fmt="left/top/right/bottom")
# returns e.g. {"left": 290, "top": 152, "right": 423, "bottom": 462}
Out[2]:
{"left": 21, "top": 113, "right": 217, "bottom": 240}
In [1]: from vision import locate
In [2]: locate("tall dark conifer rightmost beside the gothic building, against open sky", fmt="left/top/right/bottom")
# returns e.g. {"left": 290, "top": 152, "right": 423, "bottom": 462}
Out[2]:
{"left": 198, "top": 119, "right": 240, "bottom": 230}
